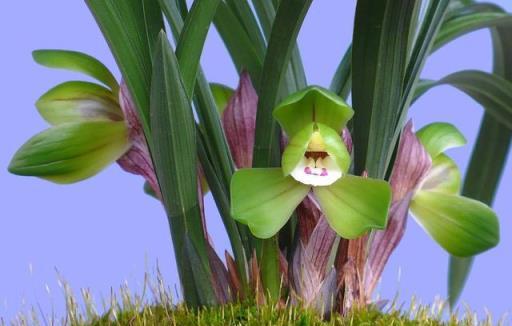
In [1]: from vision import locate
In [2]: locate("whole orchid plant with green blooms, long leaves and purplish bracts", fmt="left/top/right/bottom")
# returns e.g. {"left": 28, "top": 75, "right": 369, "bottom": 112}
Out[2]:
{"left": 9, "top": 0, "right": 512, "bottom": 315}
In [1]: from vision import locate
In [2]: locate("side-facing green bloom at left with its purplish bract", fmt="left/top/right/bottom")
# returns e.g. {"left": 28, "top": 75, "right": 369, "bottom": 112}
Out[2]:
{"left": 9, "top": 50, "right": 158, "bottom": 195}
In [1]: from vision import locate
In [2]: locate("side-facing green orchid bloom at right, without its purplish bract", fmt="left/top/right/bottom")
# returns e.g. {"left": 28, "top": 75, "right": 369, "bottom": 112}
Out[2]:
{"left": 410, "top": 123, "right": 499, "bottom": 257}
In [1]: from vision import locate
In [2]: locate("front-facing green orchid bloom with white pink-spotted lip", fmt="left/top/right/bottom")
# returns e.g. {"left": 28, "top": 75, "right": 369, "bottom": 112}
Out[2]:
{"left": 231, "top": 87, "right": 391, "bottom": 239}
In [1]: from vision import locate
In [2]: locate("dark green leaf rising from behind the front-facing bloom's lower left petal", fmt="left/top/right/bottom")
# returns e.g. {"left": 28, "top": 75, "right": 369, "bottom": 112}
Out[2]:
{"left": 253, "top": 0, "right": 312, "bottom": 167}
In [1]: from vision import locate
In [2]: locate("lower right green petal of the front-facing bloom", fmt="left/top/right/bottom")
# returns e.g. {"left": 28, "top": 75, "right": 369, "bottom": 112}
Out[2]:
{"left": 313, "top": 175, "right": 391, "bottom": 239}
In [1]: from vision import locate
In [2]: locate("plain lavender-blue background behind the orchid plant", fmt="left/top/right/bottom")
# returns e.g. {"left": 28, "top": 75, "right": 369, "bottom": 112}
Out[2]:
{"left": 0, "top": 0, "right": 512, "bottom": 320}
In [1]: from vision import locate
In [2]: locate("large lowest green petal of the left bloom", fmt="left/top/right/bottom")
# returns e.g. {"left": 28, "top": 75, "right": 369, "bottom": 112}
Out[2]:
{"left": 9, "top": 121, "right": 130, "bottom": 183}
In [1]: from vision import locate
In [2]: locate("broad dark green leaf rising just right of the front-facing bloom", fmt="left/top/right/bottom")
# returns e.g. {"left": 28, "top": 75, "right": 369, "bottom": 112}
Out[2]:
{"left": 352, "top": 0, "right": 418, "bottom": 178}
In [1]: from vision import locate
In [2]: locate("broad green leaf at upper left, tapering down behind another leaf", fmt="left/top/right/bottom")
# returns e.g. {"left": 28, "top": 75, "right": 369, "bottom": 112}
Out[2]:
{"left": 86, "top": 0, "right": 164, "bottom": 138}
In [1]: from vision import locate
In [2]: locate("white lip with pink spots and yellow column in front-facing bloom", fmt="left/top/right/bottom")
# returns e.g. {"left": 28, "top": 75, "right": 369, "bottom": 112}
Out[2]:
{"left": 291, "top": 131, "right": 343, "bottom": 186}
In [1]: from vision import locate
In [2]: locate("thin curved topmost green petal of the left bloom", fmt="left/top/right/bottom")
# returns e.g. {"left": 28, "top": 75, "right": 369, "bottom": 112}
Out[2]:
{"left": 32, "top": 50, "right": 119, "bottom": 93}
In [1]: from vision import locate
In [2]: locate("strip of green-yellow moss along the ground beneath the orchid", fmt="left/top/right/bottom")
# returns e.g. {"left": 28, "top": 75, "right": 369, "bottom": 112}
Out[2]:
{"left": 90, "top": 305, "right": 480, "bottom": 326}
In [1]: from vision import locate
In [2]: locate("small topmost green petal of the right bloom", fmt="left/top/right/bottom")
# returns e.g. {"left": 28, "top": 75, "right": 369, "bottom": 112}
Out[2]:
{"left": 416, "top": 122, "right": 466, "bottom": 158}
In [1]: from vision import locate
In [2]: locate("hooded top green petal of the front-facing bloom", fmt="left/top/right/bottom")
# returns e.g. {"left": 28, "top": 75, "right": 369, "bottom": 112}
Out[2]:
{"left": 273, "top": 86, "right": 354, "bottom": 138}
